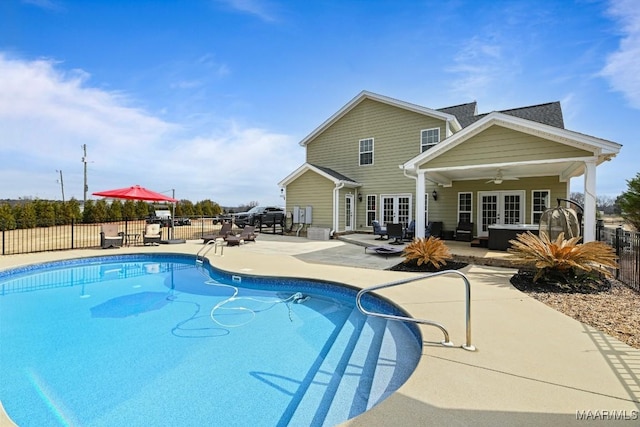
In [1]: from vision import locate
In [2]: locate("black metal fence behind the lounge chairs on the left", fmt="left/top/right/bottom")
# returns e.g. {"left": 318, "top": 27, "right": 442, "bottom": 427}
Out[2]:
{"left": 0, "top": 217, "right": 221, "bottom": 255}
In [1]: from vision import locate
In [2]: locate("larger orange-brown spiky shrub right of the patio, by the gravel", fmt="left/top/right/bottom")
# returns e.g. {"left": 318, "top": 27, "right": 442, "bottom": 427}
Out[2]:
{"left": 508, "top": 231, "right": 618, "bottom": 283}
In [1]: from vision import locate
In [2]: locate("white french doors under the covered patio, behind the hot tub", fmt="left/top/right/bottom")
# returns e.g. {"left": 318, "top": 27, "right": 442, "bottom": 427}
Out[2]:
{"left": 478, "top": 191, "right": 525, "bottom": 236}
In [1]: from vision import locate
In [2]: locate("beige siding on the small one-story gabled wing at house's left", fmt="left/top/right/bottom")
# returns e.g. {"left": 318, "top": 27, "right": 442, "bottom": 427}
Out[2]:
{"left": 286, "top": 171, "right": 335, "bottom": 228}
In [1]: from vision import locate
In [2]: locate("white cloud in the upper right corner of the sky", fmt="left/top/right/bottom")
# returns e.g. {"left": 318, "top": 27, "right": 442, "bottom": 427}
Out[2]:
{"left": 601, "top": 0, "right": 640, "bottom": 108}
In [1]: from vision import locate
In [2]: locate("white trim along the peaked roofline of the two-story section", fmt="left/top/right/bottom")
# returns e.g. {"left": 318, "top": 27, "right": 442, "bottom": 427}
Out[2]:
{"left": 300, "top": 90, "right": 462, "bottom": 147}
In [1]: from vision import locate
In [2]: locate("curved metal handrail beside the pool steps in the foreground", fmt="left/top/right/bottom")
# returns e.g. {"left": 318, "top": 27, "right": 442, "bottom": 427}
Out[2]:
{"left": 356, "top": 270, "right": 476, "bottom": 351}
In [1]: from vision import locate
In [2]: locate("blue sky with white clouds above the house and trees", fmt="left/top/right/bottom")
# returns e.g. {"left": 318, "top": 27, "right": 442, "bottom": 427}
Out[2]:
{"left": 0, "top": 0, "right": 640, "bottom": 206}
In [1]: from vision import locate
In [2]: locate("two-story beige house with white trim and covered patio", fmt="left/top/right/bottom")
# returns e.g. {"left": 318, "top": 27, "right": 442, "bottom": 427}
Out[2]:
{"left": 278, "top": 91, "right": 621, "bottom": 241}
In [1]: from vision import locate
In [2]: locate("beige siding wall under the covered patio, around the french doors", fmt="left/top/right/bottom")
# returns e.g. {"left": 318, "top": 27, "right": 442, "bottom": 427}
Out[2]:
{"left": 426, "top": 176, "right": 568, "bottom": 235}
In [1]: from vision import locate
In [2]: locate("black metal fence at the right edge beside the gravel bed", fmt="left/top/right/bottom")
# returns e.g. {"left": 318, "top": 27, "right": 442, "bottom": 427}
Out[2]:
{"left": 596, "top": 222, "right": 640, "bottom": 292}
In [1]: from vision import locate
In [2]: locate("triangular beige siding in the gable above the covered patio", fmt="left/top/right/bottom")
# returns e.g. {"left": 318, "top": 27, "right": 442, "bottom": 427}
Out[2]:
{"left": 423, "top": 125, "right": 593, "bottom": 168}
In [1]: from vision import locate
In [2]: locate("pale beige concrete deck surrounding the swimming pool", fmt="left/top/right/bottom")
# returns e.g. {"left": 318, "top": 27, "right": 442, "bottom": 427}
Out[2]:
{"left": 0, "top": 235, "right": 640, "bottom": 426}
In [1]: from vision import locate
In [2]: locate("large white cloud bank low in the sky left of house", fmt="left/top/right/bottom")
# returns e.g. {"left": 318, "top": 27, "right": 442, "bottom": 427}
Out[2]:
{"left": 0, "top": 53, "right": 304, "bottom": 205}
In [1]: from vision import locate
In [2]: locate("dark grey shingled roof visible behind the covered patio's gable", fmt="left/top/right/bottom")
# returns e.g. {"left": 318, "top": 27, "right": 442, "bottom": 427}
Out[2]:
{"left": 438, "top": 101, "right": 564, "bottom": 129}
